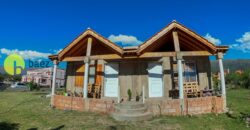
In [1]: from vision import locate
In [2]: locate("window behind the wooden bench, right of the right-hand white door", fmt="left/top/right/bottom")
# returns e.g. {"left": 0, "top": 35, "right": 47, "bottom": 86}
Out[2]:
{"left": 184, "top": 62, "right": 197, "bottom": 82}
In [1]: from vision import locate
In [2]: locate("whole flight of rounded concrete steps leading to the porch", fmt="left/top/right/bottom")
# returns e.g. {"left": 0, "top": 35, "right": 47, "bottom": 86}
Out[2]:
{"left": 111, "top": 102, "right": 152, "bottom": 121}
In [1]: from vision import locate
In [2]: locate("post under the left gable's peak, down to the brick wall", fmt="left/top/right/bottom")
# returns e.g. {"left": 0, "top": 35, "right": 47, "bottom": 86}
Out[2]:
{"left": 83, "top": 37, "right": 92, "bottom": 98}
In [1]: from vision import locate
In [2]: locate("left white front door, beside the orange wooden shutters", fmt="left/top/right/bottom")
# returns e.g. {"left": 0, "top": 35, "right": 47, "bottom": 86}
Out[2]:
{"left": 104, "top": 63, "right": 119, "bottom": 97}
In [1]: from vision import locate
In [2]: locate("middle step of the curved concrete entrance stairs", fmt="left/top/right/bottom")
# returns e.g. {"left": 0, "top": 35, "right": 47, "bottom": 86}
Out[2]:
{"left": 115, "top": 106, "right": 147, "bottom": 114}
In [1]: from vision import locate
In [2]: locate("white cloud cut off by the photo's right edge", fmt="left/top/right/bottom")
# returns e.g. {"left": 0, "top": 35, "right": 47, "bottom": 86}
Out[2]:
{"left": 233, "top": 32, "right": 250, "bottom": 53}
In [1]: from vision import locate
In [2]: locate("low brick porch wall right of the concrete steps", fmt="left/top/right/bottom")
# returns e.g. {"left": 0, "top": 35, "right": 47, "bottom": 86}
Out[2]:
{"left": 146, "top": 96, "right": 223, "bottom": 115}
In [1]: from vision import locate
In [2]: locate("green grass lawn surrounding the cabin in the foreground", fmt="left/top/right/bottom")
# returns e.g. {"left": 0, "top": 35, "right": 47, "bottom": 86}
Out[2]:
{"left": 0, "top": 89, "right": 250, "bottom": 130}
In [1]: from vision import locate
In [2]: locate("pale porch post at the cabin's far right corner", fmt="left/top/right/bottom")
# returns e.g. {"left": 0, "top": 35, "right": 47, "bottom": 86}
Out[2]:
{"left": 217, "top": 52, "right": 227, "bottom": 112}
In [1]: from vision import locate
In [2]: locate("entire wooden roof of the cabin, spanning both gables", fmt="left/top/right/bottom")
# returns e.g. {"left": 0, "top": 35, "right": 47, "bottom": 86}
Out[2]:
{"left": 49, "top": 21, "right": 228, "bottom": 60}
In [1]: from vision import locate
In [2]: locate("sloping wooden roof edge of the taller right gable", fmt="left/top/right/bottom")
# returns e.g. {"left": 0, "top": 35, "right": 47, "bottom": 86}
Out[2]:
{"left": 137, "top": 21, "right": 220, "bottom": 54}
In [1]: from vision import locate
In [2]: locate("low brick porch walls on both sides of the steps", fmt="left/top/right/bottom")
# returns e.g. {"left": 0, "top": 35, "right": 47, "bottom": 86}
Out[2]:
{"left": 54, "top": 95, "right": 223, "bottom": 115}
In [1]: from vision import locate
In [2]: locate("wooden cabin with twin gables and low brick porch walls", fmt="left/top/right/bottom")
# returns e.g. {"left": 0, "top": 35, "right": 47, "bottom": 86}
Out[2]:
{"left": 49, "top": 21, "right": 228, "bottom": 119}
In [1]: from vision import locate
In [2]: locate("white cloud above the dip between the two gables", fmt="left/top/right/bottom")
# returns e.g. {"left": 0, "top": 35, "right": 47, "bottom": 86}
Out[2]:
{"left": 108, "top": 34, "right": 142, "bottom": 46}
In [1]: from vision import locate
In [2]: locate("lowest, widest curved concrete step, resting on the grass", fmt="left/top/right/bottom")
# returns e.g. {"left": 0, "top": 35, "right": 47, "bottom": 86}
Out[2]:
{"left": 112, "top": 112, "right": 153, "bottom": 121}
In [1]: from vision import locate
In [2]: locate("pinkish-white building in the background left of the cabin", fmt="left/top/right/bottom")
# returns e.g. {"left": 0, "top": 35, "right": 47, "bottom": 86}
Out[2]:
{"left": 21, "top": 67, "right": 65, "bottom": 87}
